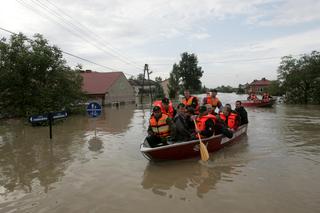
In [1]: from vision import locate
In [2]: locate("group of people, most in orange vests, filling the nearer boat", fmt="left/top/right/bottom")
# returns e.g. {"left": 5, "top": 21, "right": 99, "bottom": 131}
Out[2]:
{"left": 146, "top": 90, "right": 248, "bottom": 147}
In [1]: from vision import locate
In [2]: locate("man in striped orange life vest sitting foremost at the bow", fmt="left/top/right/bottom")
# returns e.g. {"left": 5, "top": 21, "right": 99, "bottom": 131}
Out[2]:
{"left": 146, "top": 106, "right": 176, "bottom": 147}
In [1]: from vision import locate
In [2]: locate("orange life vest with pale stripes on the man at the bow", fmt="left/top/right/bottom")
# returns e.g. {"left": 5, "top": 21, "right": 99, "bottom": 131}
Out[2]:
{"left": 149, "top": 114, "right": 170, "bottom": 137}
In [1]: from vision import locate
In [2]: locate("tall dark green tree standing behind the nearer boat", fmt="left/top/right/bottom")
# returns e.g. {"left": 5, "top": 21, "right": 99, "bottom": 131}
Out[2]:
{"left": 177, "top": 52, "right": 203, "bottom": 93}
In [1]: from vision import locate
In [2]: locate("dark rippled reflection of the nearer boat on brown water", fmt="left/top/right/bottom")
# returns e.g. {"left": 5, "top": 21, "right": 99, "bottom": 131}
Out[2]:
{"left": 141, "top": 140, "right": 248, "bottom": 199}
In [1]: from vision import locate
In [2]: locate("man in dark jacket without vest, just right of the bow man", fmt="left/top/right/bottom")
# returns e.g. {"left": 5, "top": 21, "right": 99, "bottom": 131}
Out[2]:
{"left": 173, "top": 103, "right": 192, "bottom": 141}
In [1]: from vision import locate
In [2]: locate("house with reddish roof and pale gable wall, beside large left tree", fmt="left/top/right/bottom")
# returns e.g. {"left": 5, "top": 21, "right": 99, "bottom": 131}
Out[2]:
{"left": 80, "top": 70, "right": 135, "bottom": 105}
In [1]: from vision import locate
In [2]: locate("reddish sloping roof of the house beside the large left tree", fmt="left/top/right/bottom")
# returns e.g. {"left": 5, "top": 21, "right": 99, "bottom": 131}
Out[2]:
{"left": 81, "top": 72, "right": 124, "bottom": 94}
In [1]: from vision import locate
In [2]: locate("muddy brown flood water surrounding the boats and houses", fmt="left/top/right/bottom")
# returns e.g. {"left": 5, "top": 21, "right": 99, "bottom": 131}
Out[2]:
{"left": 0, "top": 94, "right": 320, "bottom": 213}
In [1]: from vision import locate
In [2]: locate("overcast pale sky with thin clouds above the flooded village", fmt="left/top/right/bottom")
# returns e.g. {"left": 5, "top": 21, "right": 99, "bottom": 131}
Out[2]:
{"left": 0, "top": 0, "right": 320, "bottom": 88}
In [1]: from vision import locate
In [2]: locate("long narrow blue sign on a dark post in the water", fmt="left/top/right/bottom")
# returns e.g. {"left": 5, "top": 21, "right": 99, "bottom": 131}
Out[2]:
{"left": 29, "top": 111, "right": 68, "bottom": 139}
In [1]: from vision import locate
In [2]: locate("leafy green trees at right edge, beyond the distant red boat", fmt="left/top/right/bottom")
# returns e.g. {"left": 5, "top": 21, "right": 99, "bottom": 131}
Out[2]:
{"left": 278, "top": 51, "right": 320, "bottom": 104}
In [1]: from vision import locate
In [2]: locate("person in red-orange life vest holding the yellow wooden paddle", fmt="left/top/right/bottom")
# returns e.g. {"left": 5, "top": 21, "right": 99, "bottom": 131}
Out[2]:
{"left": 194, "top": 106, "right": 216, "bottom": 138}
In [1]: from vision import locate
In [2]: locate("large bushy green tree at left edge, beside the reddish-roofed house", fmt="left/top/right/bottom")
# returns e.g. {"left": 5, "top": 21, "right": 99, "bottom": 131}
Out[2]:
{"left": 0, "top": 34, "right": 84, "bottom": 116}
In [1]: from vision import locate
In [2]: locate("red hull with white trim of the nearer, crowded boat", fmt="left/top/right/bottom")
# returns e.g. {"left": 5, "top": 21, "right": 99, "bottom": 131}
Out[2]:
{"left": 140, "top": 124, "right": 247, "bottom": 160}
